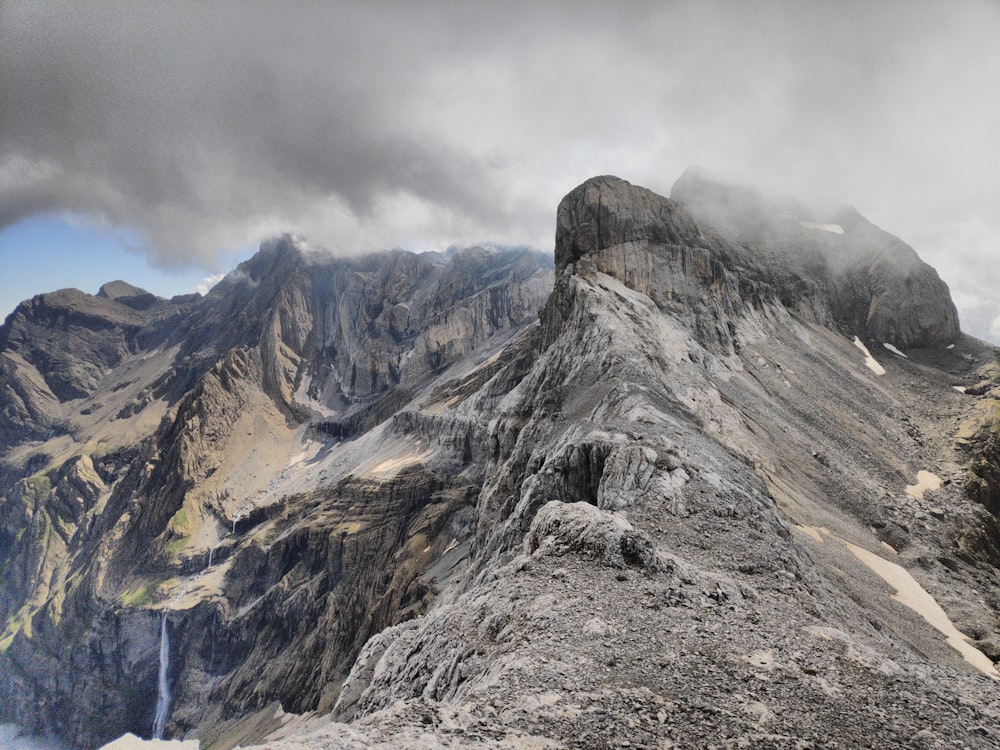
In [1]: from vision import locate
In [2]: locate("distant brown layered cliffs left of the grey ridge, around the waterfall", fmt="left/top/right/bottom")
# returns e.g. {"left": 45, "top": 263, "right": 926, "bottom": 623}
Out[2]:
{"left": 0, "top": 238, "right": 551, "bottom": 746}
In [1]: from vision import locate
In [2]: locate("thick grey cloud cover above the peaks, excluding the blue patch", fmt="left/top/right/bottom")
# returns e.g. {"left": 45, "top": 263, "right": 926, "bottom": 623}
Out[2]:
{"left": 0, "top": 0, "right": 1000, "bottom": 342}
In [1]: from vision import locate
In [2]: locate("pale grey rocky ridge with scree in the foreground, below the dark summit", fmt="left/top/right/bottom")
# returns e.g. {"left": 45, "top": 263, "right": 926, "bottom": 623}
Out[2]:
{"left": 304, "top": 178, "right": 1000, "bottom": 748}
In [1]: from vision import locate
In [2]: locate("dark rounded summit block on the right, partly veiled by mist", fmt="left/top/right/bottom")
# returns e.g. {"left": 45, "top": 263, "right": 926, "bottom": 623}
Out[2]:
{"left": 556, "top": 169, "right": 959, "bottom": 349}
